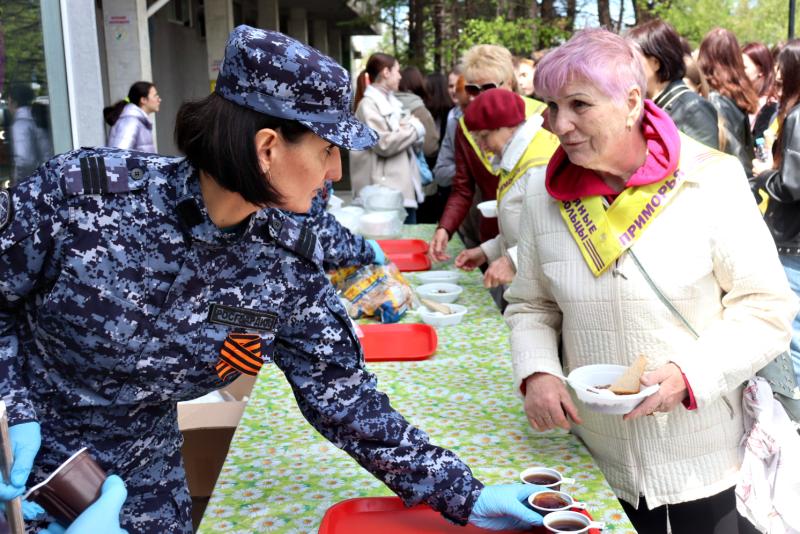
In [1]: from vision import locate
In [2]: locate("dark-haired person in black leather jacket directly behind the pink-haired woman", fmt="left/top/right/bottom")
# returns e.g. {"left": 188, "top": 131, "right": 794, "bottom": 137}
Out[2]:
{"left": 628, "top": 19, "right": 719, "bottom": 149}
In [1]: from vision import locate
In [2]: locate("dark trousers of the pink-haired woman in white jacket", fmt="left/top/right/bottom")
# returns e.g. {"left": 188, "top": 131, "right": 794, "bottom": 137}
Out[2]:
{"left": 619, "top": 488, "right": 758, "bottom": 534}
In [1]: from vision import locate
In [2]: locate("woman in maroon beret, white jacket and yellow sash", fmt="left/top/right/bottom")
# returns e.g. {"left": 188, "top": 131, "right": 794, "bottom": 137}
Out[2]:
{"left": 455, "top": 89, "right": 558, "bottom": 294}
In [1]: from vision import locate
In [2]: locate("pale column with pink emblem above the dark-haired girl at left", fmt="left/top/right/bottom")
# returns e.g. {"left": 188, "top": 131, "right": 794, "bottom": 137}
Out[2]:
{"left": 103, "top": 0, "right": 152, "bottom": 102}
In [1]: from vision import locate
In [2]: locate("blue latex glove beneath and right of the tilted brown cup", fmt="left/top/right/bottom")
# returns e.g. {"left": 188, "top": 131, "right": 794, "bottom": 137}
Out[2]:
{"left": 40, "top": 475, "right": 128, "bottom": 534}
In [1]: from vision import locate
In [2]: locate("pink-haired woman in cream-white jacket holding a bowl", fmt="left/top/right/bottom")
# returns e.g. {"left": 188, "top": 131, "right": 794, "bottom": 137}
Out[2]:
{"left": 505, "top": 29, "right": 798, "bottom": 534}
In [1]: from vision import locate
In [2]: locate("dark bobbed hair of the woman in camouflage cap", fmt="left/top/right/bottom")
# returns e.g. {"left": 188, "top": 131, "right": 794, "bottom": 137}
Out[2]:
{"left": 175, "top": 93, "right": 310, "bottom": 206}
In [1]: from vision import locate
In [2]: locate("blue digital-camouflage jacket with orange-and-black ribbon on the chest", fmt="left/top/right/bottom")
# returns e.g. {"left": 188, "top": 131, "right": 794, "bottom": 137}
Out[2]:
{"left": 0, "top": 149, "right": 482, "bottom": 523}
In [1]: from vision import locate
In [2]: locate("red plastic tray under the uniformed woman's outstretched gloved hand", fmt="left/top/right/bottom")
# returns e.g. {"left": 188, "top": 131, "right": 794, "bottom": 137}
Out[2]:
{"left": 319, "top": 497, "right": 600, "bottom": 534}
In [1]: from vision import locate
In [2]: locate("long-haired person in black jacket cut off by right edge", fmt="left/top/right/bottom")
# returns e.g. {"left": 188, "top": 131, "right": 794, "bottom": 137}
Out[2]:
{"left": 753, "top": 39, "right": 800, "bottom": 390}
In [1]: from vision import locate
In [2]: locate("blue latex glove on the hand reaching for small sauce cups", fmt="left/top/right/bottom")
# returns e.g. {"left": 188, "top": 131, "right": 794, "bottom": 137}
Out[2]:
{"left": 469, "top": 484, "right": 547, "bottom": 530}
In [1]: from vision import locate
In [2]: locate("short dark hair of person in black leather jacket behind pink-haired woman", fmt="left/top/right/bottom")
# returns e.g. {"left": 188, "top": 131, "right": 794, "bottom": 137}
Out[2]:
{"left": 628, "top": 19, "right": 686, "bottom": 82}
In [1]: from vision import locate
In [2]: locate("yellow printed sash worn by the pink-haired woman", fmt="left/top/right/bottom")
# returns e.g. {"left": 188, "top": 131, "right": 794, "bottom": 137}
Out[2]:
{"left": 561, "top": 142, "right": 727, "bottom": 276}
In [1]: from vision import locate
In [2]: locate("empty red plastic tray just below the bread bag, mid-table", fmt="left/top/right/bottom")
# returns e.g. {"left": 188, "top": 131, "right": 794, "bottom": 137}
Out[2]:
{"left": 359, "top": 323, "right": 439, "bottom": 362}
